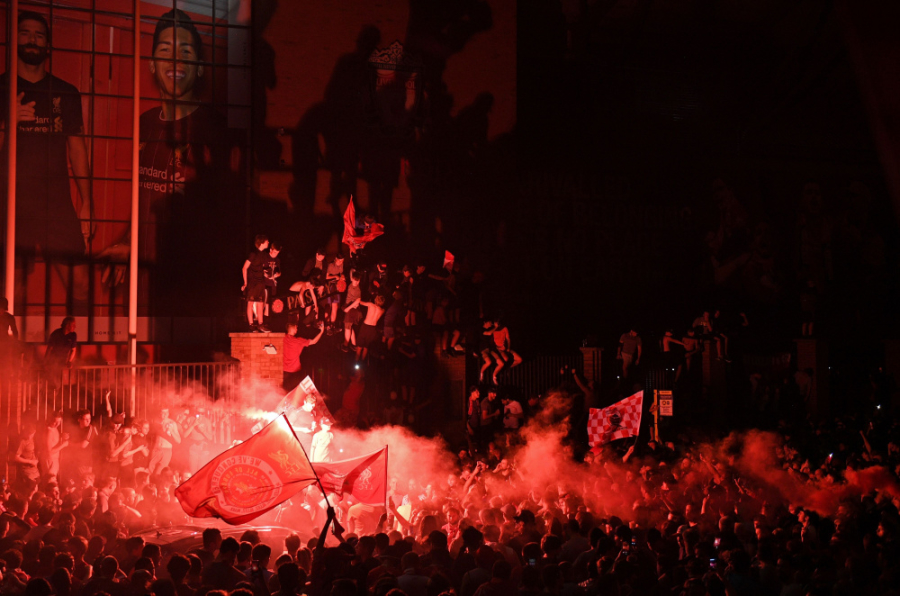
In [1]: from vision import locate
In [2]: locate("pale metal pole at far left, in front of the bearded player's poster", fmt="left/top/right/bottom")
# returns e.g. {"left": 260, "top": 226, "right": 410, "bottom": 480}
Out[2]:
{"left": 4, "top": 0, "right": 19, "bottom": 314}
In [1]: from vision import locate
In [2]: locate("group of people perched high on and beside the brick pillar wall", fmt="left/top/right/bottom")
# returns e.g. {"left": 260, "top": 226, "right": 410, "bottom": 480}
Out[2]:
{"left": 243, "top": 235, "right": 522, "bottom": 422}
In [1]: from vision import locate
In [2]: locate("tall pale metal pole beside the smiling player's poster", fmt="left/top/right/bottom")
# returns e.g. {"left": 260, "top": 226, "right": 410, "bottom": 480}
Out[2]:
{"left": 128, "top": 0, "right": 141, "bottom": 416}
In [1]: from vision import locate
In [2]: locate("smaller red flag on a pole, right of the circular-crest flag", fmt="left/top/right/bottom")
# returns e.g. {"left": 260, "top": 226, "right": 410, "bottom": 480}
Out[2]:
{"left": 312, "top": 447, "right": 387, "bottom": 505}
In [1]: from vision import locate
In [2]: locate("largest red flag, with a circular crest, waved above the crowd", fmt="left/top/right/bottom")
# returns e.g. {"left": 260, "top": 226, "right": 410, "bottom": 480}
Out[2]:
{"left": 175, "top": 414, "right": 316, "bottom": 524}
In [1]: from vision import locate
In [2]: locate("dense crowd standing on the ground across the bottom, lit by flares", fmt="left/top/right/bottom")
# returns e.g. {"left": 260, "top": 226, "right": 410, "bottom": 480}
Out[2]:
{"left": 0, "top": 358, "right": 900, "bottom": 596}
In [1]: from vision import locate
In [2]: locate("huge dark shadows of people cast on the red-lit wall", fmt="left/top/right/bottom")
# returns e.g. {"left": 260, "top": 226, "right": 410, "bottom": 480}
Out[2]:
{"left": 251, "top": 0, "right": 514, "bottom": 268}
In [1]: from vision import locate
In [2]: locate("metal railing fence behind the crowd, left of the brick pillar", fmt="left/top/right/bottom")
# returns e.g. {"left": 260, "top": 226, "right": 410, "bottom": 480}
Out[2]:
{"left": 0, "top": 362, "right": 240, "bottom": 430}
